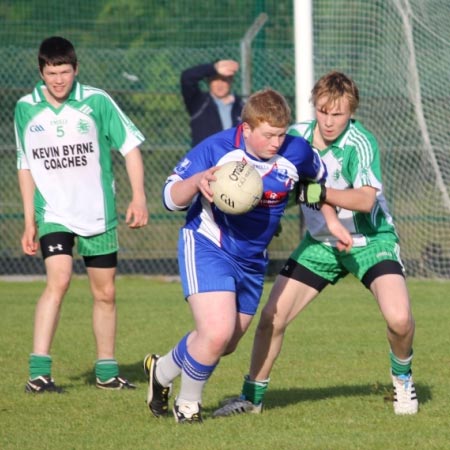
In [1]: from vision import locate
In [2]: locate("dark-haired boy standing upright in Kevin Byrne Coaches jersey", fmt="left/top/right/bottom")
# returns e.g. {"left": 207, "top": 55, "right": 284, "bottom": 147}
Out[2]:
{"left": 14, "top": 36, "right": 148, "bottom": 393}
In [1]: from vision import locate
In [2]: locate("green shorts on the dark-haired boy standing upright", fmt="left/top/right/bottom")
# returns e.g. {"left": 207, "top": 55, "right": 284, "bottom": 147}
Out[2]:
{"left": 38, "top": 222, "right": 119, "bottom": 256}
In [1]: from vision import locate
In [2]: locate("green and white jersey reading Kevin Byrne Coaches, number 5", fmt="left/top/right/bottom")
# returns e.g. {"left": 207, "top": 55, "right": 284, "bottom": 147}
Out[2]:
{"left": 14, "top": 81, "right": 144, "bottom": 236}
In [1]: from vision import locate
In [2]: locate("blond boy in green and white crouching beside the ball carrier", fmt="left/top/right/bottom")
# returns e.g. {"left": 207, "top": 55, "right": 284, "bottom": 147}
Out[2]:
{"left": 214, "top": 72, "right": 418, "bottom": 417}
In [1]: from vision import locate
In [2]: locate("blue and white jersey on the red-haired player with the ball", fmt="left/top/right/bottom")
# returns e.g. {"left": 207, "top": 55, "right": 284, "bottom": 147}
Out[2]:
{"left": 163, "top": 125, "right": 326, "bottom": 263}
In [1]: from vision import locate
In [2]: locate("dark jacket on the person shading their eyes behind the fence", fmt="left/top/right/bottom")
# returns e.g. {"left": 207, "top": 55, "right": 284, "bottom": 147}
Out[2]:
{"left": 181, "top": 63, "right": 244, "bottom": 146}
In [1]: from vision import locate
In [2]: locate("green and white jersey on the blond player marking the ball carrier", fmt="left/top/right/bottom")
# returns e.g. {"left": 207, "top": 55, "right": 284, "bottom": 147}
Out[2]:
{"left": 288, "top": 120, "right": 398, "bottom": 247}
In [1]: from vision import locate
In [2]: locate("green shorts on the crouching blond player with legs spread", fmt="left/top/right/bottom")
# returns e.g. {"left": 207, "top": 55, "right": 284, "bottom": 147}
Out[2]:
{"left": 290, "top": 233, "right": 403, "bottom": 284}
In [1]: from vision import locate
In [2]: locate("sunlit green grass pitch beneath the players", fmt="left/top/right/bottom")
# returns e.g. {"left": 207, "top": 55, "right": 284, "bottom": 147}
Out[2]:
{"left": 0, "top": 277, "right": 450, "bottom": 450}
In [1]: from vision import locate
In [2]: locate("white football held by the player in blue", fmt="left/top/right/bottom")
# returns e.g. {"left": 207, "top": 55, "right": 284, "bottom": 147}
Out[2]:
{"left": 210, "top": 161, "right": 263, "bottom": 214}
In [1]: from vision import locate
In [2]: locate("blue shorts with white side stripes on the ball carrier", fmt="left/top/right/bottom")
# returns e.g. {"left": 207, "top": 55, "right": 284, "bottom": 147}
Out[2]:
{"left": 178, "top": 228, "right": 267, "bottom": 316}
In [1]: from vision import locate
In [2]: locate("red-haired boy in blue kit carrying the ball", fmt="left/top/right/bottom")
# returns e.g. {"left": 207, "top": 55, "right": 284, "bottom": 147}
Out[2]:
{"left": 144, "top": 89, "right": 351, "bottom": 423}
